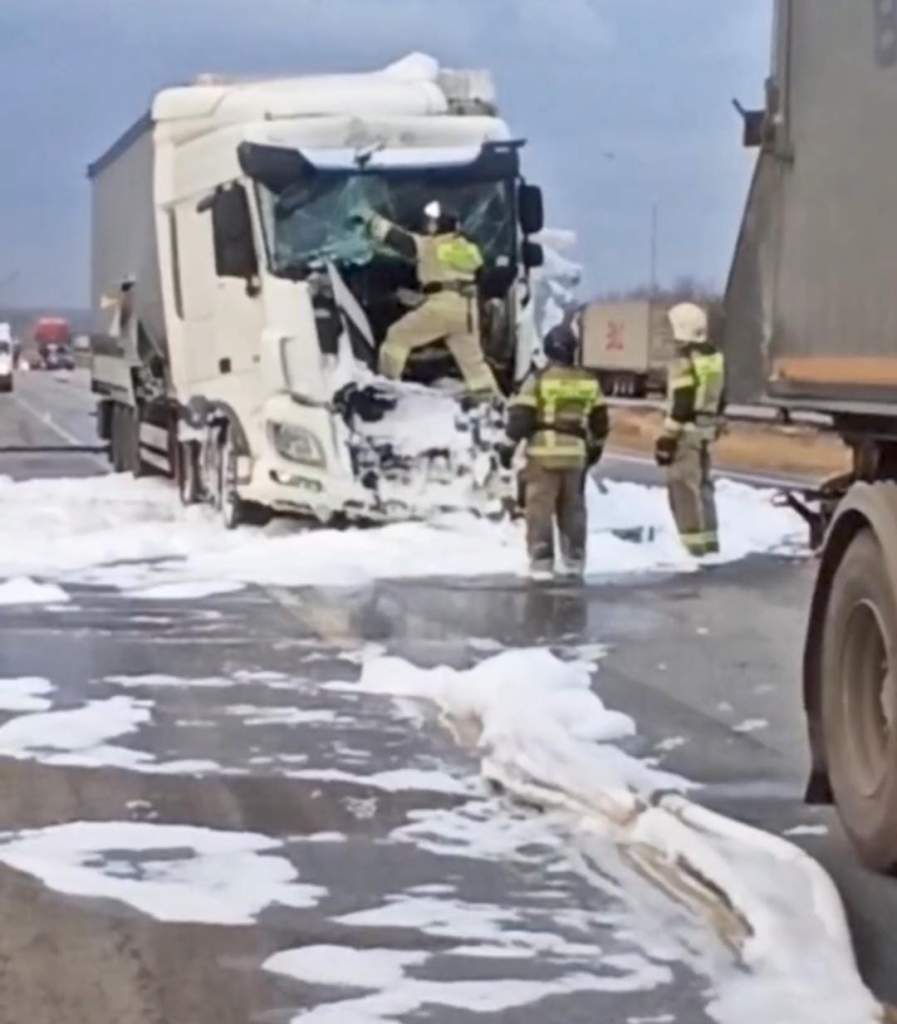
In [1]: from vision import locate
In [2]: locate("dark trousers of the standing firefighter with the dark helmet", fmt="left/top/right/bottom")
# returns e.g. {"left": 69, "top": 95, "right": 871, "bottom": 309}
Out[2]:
{"left": 526, "top": 459, "right": 587, "bottom": 571}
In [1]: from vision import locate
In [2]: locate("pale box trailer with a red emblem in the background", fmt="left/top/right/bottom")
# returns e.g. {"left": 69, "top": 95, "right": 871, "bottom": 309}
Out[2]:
{"left": 581, "top": 300, "right": 674, "bottom": 398}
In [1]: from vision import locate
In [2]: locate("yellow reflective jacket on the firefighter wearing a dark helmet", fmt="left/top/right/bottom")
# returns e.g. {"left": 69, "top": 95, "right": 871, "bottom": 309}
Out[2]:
{"left": 511, "top": 367, "right": 604, "bottom": 469}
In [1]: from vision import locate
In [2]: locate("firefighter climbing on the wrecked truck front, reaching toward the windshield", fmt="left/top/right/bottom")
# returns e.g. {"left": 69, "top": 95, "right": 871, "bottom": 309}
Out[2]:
{"left": 358, "top": 202, "right": 499, "bottom": 395}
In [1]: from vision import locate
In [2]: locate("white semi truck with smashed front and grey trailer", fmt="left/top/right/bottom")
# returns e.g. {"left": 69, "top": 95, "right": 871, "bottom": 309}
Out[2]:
{"left": 89, "top": 55, "right": 543, "bottom": 526}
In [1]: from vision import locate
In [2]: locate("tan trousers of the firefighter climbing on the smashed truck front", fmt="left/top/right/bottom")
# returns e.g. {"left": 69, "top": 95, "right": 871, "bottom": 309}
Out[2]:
{"left": 380, "top": 295, "right": 499, "bottom": 393}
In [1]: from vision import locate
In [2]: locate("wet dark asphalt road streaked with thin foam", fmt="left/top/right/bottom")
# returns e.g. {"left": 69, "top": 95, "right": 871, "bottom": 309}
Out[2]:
{"left": 0, "top": 375, "right": 897, "bottom": 1024}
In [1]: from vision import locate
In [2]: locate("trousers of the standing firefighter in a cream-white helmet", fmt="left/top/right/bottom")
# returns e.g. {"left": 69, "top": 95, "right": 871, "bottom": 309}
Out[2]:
{"left": 667, "top": 434, "right": 720, "bottom": 557}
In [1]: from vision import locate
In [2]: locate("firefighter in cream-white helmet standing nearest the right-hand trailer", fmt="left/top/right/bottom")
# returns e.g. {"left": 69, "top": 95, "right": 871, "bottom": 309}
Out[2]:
{"left": 654, "top": 302, "right": 725, "bottom": 558}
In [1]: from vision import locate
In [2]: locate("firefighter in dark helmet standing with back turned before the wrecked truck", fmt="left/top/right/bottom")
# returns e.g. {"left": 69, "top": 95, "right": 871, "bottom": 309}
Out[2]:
{"left": 505, "top": 324, "right": 608, "bottom": 580}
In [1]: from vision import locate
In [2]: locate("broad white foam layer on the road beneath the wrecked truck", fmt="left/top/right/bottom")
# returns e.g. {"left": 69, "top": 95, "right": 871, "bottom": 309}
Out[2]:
{"left": 0, "top": 475, "right": 805, "bottom": 601}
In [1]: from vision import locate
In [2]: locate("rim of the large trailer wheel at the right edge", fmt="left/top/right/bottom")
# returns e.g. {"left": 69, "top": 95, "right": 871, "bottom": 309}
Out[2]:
{"left": 840, "top": 600, "right": 893, "bottom": 798}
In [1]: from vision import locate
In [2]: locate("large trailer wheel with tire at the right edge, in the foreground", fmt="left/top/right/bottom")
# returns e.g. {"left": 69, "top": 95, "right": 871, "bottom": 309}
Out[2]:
{"left": 821, "top": 529, "right": 897, "bottom": 870}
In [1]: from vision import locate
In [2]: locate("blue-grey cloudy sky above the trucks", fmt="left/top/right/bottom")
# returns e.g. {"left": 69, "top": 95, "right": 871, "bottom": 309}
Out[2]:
{"left": 0, "top": 0, "right": 771, "bottom": 306}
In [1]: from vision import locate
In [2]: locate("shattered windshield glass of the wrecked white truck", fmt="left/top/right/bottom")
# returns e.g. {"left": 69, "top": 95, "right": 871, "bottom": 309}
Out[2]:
{"left": 265, "top": 174, "right": 515, "bottom": 273}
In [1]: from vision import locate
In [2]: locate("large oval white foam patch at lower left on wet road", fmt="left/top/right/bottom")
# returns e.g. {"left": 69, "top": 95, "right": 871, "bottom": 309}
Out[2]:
{"left": 0, "top": 821, "right": 326, "bottom": 925}
